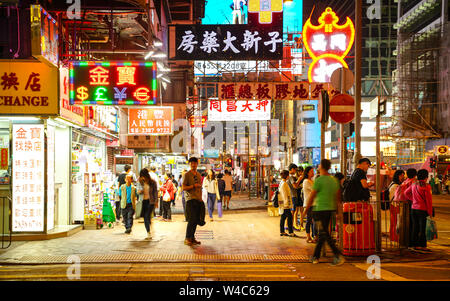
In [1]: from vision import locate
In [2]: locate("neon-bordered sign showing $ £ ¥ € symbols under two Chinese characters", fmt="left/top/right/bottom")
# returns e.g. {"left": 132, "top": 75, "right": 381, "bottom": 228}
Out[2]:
{"left": 69, "top": 61, "right": 158, "bottom": 105}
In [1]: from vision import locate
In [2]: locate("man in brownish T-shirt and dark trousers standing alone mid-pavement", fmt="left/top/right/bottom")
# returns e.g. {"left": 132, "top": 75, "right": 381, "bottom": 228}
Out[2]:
{"left": 183, "top": 157, "right": 203, "bottom": 246}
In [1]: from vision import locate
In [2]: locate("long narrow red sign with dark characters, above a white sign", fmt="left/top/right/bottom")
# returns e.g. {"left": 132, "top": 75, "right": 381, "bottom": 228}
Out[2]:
{"left": 218, "top": 82, "right": 329, "bottom": 100}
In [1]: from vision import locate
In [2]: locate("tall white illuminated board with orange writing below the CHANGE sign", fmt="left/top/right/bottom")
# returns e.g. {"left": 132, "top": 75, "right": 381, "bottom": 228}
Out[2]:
{"left": 12, "top": 124, "right": 45, "bottom": 232}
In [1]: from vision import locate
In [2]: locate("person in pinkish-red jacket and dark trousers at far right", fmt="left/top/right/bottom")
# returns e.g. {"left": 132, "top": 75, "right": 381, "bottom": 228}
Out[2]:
{"left": 405, "top": 169, "right": 433, "bottom": 252}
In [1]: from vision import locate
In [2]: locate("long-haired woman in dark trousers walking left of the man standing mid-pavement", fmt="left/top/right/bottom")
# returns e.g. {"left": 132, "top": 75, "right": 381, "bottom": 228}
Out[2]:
{"left": 138, "top": 168, "right": 158, "bottom": 239}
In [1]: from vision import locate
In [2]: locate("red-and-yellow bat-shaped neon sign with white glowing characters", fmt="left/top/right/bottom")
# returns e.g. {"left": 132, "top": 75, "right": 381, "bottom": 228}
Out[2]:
{"left": 303, "top": 7, "right": 355, "bottom": 83}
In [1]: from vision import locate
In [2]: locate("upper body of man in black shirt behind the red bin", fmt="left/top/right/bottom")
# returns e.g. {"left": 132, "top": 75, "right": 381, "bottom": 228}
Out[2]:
{"left": 344, "top": 158, "right": 375, "bottom": 202}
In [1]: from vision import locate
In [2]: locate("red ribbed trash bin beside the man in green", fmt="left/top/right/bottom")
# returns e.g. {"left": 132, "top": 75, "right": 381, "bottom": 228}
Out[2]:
{"left": 342, "top": 202, "right": 375, "bottom": 256}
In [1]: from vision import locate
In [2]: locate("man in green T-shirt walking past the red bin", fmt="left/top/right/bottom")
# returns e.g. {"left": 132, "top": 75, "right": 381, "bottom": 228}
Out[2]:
{"left": 304, "top": 159, "right": 345, "bottom": 265}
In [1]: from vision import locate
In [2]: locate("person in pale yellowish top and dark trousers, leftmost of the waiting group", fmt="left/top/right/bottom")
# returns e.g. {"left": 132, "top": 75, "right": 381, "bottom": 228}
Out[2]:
{"left": 278, "top": 170, "right": 297, "bottom": 237}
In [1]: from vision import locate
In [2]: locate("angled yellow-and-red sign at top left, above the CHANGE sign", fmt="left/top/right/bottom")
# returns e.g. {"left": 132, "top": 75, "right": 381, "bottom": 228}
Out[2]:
{"left": 30, "top": 5, "right": 59, "bottom": 66}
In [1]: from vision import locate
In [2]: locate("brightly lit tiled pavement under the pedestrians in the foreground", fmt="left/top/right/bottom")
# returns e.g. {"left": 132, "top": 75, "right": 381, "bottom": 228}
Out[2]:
{"left": 0, "top": 195, "right": 444, "bottom": 264}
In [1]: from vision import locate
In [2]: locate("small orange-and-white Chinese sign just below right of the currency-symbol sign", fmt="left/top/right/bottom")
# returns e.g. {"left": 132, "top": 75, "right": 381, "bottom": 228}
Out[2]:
{"left": 128, "top": 107, "right": 173, "bottom": 135}
